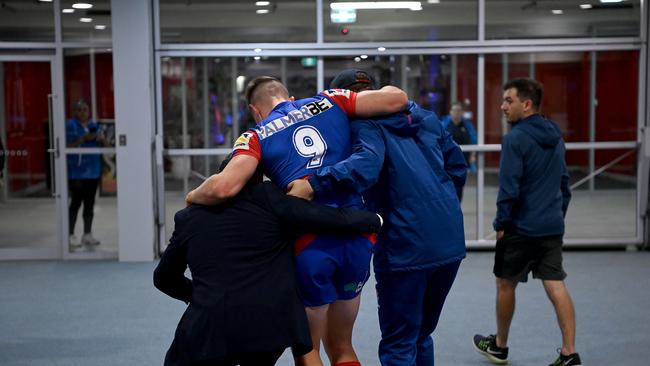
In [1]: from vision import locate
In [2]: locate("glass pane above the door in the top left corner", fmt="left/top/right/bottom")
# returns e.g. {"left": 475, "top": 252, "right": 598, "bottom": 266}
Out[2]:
{"left": 0, "top": 0, "right": 54, "bottom": 42}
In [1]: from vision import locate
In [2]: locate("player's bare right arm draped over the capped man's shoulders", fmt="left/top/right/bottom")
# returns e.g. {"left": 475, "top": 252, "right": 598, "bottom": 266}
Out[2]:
{"left": 355, "top": 85, "right": 408, "bottom": 117}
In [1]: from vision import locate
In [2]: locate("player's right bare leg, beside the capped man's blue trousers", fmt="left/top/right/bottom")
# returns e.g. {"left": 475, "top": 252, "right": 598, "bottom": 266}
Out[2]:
{"left": 323, "top": 296, "right": 361, "bottom": 365}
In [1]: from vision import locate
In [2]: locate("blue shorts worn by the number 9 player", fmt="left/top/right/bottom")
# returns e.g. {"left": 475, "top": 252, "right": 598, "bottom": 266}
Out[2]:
{"left": 296, "top": 235, "right": 374, "bottom": 307}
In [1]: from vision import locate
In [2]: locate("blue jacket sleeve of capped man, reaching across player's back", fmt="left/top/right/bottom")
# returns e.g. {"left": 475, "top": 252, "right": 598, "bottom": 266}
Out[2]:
{"left": 309, "top": 120, "right": 386, "bottom": 197}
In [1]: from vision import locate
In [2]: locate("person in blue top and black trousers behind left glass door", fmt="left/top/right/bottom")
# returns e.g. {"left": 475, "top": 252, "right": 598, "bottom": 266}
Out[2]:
{"left": 66, "top": 100, "right": 106, "bottom": 249}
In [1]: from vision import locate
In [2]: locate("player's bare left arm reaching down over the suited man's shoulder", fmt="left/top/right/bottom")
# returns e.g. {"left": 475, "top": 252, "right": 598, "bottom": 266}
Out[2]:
{"left": 185, "top": 154, "right": 259, "bottom": 205}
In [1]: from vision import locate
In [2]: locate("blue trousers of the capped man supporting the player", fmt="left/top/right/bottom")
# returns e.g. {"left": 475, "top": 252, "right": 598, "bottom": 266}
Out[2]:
{"left": 375, "top": 261, "right": 460, "bottom": 366}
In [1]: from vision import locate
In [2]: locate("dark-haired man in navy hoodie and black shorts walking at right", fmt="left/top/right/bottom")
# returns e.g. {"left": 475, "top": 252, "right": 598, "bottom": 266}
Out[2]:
{"left": 474, "top": 79, "right": 581, "bottom": 366}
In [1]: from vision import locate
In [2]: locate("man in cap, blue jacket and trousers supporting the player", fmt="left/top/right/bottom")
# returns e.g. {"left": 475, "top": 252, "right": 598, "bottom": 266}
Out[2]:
{"left": 289, "top": 70, "right": 467, "bottom": 366}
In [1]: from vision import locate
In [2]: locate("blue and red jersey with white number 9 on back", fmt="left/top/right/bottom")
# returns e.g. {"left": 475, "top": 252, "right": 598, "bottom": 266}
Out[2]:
{"left": 233, "top": 89, "right": 362, "bottom": 207}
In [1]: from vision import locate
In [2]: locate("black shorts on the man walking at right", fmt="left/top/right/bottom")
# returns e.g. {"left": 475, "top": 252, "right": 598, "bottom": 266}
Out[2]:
{"left": 493, "top": 232, "right": 566, "bottom": 282}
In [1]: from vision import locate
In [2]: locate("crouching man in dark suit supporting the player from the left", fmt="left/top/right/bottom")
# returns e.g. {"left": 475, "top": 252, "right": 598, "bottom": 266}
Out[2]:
{"left": 154, "top": 157, "right": 381, "bottom": 366}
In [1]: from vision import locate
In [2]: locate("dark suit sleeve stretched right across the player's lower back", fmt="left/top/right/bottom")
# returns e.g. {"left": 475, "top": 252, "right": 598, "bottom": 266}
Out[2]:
{"left": 262, "top": 182, "right": 381, "bottom": 233}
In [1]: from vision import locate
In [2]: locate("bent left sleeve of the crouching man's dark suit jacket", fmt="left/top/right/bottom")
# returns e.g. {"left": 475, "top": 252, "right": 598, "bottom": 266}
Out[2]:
{"left": 153, "top": 210, "right": 192, "bottom": 303}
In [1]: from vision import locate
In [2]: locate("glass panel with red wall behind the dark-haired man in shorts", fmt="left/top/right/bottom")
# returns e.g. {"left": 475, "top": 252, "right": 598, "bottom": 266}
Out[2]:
{"left": 485, "top": 51, "right": 639, "bottom": 144}
